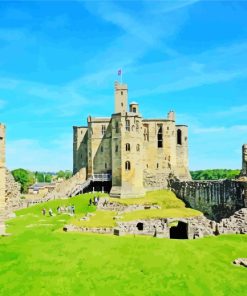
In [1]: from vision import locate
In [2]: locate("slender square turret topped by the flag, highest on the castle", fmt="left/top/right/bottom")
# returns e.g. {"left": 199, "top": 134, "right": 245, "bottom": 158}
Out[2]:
{"left": 115, "top": 81, "right": 128, "bottom": 114}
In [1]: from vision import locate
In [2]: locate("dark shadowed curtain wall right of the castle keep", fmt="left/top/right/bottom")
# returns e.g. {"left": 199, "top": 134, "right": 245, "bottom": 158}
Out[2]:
{"left": 170, "top": 180, "right": 247, "bottom": 221}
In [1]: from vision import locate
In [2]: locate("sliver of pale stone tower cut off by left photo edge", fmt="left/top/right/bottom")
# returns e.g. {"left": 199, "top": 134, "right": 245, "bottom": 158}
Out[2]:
{"left": 0, "top": 123, "right": 6, "bottom": 212}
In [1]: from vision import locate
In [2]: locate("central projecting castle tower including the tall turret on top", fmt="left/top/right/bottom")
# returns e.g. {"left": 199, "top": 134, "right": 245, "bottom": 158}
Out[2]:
{"left": 110, "top": 83, "right": 145, "bottom": 198}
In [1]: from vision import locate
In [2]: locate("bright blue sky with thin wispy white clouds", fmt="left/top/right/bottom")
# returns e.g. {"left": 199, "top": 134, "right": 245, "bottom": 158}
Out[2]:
{"left": 0, "top": 0, "right": 247, "bottom": 171}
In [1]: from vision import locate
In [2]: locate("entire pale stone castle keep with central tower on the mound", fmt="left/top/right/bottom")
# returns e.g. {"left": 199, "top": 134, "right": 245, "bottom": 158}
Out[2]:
{"left": 73, "top": 82, "right": 191, "bottom": 197}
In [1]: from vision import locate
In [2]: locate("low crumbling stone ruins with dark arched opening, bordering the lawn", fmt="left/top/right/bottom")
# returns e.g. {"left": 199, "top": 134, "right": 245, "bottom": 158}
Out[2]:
{"left": 64, "top": 208, "right": 247, "bottom": 239}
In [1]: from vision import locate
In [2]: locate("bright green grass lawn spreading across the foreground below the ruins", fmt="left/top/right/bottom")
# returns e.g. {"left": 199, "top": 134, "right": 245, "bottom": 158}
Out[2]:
{"left": 0, "top": 195, "right": 247, "bottom": 296}
